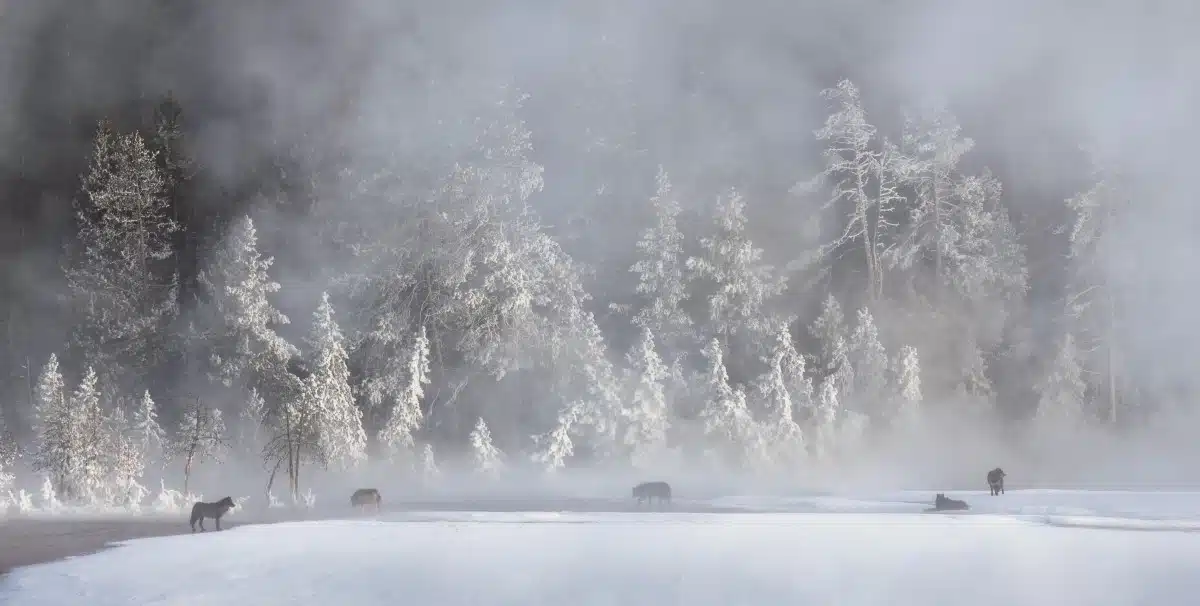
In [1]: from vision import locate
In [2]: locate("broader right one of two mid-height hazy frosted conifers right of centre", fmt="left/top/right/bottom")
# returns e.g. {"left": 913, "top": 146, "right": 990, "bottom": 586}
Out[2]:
{"left": 688, "top": 184, "right": 787, "bottom": 354}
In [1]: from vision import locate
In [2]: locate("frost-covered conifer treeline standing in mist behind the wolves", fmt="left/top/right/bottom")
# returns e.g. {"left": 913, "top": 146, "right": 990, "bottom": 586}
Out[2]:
{"left": 0, "top": 80, "right": 1147, "bottom": 503}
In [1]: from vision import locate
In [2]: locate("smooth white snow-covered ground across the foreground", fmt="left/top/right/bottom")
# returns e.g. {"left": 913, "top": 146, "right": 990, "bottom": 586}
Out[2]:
{"left": 0, "top": 491, "right": 1200, "bottom": 606}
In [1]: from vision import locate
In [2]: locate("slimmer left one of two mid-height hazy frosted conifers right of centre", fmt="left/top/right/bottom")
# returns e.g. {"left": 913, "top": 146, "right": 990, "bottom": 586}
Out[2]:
{"left": 630, "top": 167, "right": 692, "bottom": 352}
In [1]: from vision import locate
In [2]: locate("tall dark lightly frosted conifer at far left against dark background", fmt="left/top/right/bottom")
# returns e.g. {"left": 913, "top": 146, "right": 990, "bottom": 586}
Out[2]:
{"left": 66, "top": 121, "right": 179, "bottom": 391}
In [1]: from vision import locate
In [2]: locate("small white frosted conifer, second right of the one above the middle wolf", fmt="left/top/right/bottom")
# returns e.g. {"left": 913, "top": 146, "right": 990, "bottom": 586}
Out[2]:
{"left": 756, "top": 329, "right": 812, "bottom": 466}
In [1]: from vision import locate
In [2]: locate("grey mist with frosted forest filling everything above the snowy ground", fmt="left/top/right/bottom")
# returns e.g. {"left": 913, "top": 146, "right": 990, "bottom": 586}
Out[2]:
{"left": 0, "top": 0, "right": 1200, "bottom": 506}
